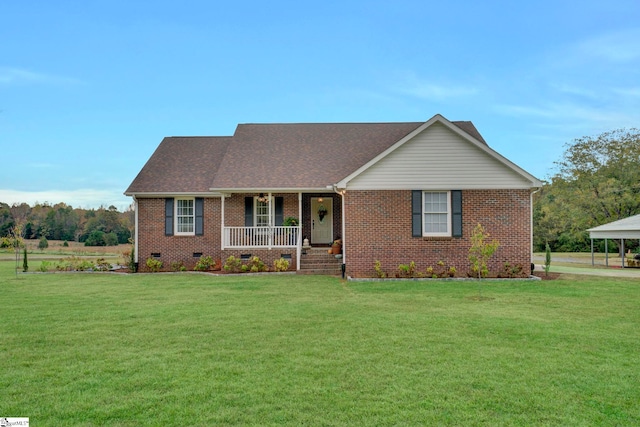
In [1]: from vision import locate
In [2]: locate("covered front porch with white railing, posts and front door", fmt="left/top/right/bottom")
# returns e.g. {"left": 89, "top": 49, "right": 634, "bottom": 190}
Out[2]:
{"left": 221, "top": 191, "right": 344, "bottom": 270}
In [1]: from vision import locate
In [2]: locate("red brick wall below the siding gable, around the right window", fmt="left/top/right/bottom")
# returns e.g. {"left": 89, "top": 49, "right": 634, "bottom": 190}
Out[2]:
{"left": 344, "top": 190, "right": 531, "bottom": 277}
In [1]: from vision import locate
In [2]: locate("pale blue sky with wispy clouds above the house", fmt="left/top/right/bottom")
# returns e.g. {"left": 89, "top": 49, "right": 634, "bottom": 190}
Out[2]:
{"left": 0, "top": 0, "right": 640, "bottom": 210}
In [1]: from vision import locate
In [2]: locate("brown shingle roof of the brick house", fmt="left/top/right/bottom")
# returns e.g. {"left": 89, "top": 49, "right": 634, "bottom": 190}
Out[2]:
{"left": 125, "top": 122, "right": 486, "bottom": 195}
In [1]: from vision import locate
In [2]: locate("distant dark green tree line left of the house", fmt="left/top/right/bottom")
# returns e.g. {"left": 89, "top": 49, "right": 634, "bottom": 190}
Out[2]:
{"left": 0, "top": 202, "right": 134, "bottom": 246}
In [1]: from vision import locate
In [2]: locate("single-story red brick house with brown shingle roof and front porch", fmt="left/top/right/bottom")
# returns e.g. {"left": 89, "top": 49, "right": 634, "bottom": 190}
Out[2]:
{"left": 125, "top": 115, "right": 542, "bottom": 277}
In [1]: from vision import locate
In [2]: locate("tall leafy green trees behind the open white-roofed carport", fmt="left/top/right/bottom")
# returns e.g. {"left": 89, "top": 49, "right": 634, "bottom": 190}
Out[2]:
{"left": 533, "top": 129, "right": 640, "bottom": 252}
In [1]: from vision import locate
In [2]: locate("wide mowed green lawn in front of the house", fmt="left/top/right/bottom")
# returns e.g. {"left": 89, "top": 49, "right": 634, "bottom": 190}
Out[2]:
{"left": 0, "top": 262, "right": 640, "bottom": 426}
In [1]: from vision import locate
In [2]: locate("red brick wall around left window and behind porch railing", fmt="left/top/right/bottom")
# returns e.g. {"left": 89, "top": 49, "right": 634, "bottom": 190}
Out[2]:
{"left": 138, "top": 194, "right": 298, "bottom": 272}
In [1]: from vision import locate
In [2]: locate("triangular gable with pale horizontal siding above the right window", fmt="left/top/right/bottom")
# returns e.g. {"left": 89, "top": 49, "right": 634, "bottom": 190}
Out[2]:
{"left": 337, "top": 114, "right": 542, "bottom": 189}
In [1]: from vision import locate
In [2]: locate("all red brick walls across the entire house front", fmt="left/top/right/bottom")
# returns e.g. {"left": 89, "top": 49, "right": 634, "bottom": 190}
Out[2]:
{"left": 138, "top": 190, "right": 531, "bottom": 277}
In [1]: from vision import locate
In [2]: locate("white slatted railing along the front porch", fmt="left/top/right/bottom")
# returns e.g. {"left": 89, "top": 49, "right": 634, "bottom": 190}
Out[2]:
{"left": 224, "top": 226, "right": 301, "bottom": 249}
